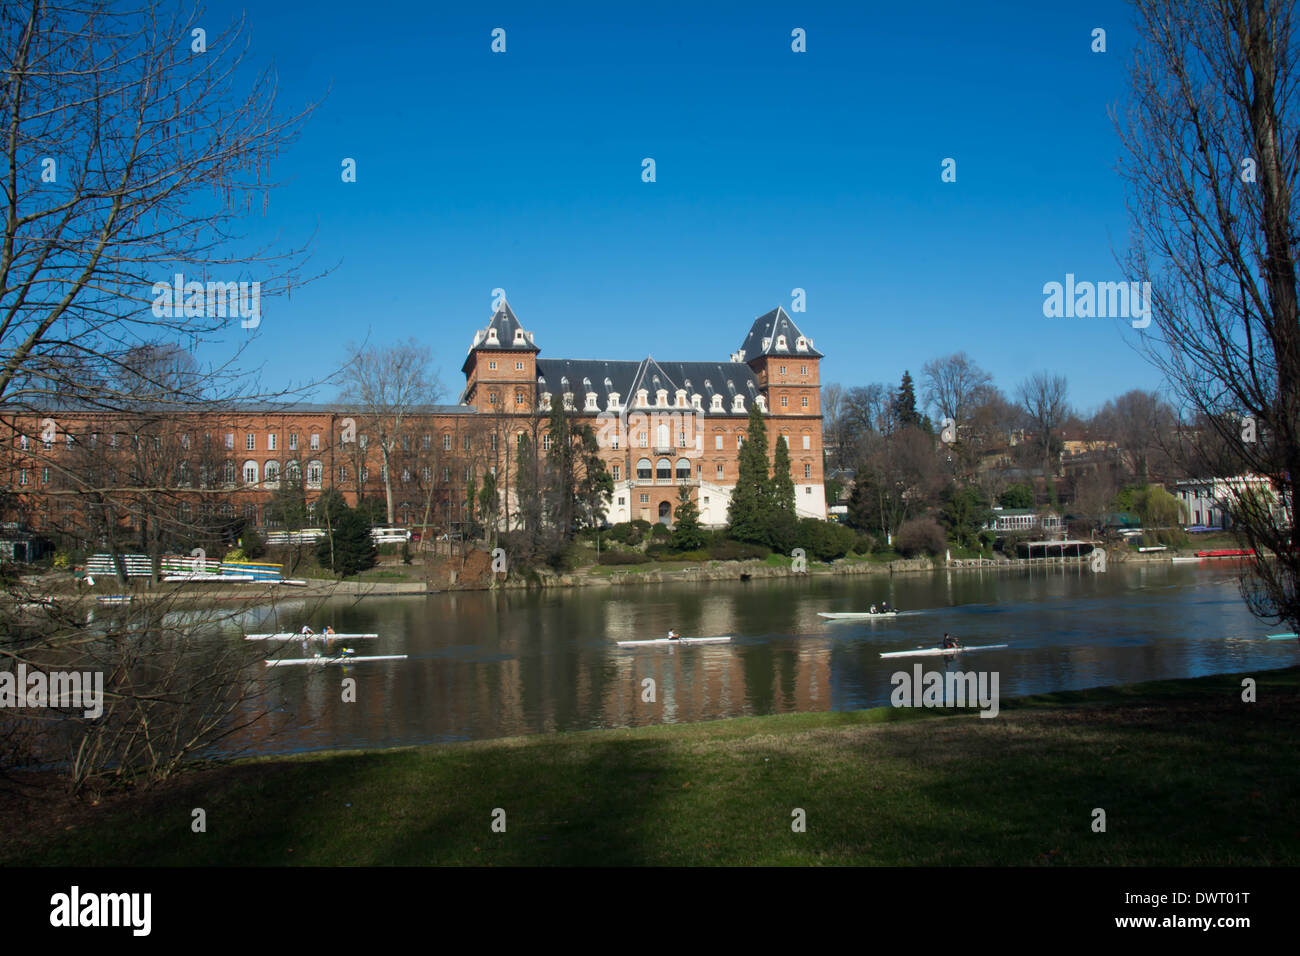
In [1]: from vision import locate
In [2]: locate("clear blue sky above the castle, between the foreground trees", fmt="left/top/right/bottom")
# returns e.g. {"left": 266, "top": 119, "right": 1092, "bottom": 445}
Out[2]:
{"left": 205, "top": 0, "right": 1160, "bottom": 411}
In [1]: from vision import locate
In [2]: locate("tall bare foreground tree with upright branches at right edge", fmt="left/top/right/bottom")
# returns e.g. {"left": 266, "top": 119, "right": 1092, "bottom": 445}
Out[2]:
{"left": 1118, "top": 0, "right": 1300, "bottom": 627}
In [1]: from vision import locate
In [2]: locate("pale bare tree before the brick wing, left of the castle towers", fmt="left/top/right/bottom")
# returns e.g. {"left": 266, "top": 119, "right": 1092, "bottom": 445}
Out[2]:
{"left": 339, "top": 338, "right": 442, "bottom": 524}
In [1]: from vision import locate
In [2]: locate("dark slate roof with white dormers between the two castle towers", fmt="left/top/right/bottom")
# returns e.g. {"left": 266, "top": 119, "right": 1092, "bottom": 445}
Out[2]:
{"left": 537, "top": 356, "right": 762, "bottom": 415}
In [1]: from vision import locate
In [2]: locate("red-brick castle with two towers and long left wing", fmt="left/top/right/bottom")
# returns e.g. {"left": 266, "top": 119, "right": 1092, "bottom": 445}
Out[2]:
{"left": 4, "top": 302, "right": 827, "bottom": 541}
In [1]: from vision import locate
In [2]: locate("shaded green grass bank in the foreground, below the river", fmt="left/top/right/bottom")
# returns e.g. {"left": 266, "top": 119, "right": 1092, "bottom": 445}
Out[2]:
{"left": 0, "top": 667, "right": 1300, "bottom": 866}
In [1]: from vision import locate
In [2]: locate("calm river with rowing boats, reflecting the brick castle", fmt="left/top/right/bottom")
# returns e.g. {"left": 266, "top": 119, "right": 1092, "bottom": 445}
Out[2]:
{"left": 220, "top": 563, "right": 1300, "bottom": 753}
